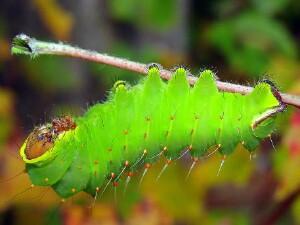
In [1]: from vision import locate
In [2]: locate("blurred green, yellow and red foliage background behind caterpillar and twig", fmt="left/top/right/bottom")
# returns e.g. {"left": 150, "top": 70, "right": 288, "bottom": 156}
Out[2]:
{"left": 0, "top": 0, "right": 300, "bottom": 225}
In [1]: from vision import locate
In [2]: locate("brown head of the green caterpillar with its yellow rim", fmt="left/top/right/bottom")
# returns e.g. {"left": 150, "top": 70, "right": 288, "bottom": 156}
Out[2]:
{"left": 20, "top": 116, "right": 76, "bottom": 163}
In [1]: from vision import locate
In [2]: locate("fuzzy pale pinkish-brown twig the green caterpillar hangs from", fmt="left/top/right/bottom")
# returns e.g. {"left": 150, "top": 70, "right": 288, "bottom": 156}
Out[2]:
{"left": 11, "top": 34, "right": 300, "bottom": 108}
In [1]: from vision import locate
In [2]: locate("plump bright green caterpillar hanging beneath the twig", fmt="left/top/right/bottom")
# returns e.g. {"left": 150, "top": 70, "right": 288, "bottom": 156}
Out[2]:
{"left": 20, "top": 66, "right": 285, "bottom": 198}
